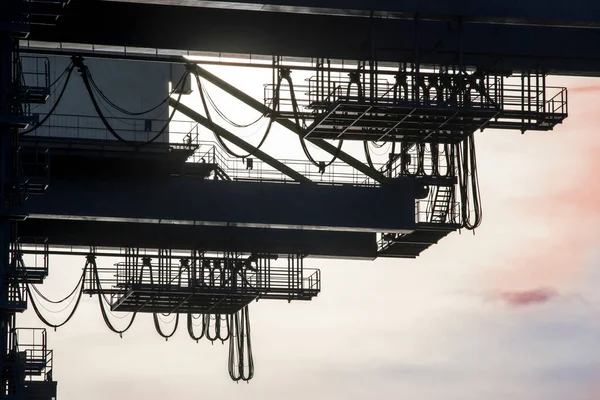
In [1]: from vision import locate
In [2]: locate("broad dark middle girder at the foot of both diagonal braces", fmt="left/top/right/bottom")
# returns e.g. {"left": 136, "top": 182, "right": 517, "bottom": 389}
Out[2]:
{"left": 23, "top": 176, "right": 415, "bottom": 233}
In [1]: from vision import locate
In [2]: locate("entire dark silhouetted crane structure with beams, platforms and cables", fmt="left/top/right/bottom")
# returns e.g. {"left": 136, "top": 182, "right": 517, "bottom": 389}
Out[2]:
{"left": 0, "top": 0, "right": 600, "bottom": 399}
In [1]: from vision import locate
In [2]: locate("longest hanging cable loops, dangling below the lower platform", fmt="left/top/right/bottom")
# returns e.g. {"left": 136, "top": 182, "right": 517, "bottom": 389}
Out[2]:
{"left": 228, "top": 306, "right": 254, "bottom": 382}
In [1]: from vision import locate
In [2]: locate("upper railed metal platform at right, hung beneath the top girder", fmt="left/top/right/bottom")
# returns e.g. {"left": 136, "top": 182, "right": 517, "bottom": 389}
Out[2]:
{"left": 265, "top": 62, "right": 567, "bottom": 143}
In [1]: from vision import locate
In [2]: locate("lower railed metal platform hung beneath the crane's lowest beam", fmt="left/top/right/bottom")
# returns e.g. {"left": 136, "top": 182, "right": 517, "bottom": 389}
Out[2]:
{"left": 85, "top": 252, "right": 321, "bottom": 314}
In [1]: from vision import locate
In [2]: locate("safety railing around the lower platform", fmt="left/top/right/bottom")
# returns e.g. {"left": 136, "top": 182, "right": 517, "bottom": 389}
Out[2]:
{"left": 85, "top": 258, "right": 321, "bottom": 306}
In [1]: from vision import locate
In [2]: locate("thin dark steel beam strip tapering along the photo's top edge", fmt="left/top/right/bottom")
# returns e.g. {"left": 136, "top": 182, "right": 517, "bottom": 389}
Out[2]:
{"left": 98, "top": 0, "right": 600, "bottom": 28}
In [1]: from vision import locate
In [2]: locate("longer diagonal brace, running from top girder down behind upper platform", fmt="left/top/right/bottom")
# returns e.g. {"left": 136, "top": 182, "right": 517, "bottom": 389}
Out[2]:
{"left": 188, "top": 64, "right": 388, "bottom": 183}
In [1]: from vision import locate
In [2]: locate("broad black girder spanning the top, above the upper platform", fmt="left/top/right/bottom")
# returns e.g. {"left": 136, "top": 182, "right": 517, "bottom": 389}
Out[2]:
{"left": 29, "top": 0, "right": 600, "bottom": 76}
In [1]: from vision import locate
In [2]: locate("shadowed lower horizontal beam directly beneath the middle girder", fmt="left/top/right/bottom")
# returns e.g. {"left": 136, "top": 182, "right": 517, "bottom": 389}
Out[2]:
{"left": 19, "top": 219, "right": 377, "bottom": 260}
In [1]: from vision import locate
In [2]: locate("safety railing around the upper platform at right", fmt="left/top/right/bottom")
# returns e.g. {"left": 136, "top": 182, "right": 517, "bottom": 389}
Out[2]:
{"left": 265, "top": 69, "right": 567, "bottom": 126}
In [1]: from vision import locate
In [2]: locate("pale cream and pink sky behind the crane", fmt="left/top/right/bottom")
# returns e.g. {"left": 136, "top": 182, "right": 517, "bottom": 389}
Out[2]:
{"left": 19, "top": 64, "right": 600, "bottom": 400}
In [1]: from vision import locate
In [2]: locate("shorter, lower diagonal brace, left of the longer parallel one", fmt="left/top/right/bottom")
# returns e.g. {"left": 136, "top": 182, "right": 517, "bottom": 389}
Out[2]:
{"left": 169, "top": 98, "right": 312, "bottom": 183}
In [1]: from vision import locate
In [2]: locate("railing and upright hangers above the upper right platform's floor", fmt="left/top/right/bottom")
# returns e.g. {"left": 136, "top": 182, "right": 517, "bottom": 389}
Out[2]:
{"left": 264, "top": 66, "right": 567, "bottom": 131}
